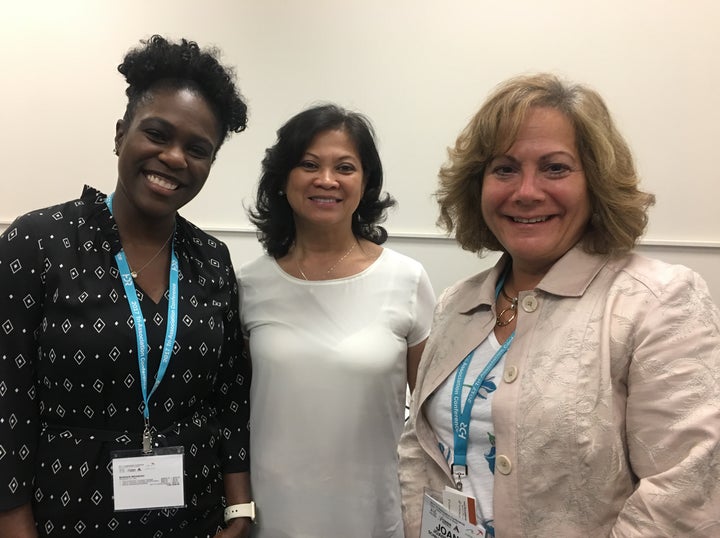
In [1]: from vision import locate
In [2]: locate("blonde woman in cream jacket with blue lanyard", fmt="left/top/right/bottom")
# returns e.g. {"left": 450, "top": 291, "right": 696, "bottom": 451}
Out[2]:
{"left": 400, "top": 74, "right": 720, "bottom": 538}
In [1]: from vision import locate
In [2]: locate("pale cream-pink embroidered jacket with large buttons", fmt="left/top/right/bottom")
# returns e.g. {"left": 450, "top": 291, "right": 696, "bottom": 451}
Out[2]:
{"left": 400, "top": 248, "right": 720, "bottom": 538}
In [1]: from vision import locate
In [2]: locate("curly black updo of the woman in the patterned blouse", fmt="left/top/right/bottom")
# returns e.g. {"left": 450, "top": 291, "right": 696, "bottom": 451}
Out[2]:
{"left": 118, "top": 35, "right": 247, "bottom": 149}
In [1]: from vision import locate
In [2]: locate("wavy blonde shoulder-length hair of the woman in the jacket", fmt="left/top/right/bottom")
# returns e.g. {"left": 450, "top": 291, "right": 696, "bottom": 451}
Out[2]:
{"left": 435, "top": 73, "right": 655, "bottom": 254}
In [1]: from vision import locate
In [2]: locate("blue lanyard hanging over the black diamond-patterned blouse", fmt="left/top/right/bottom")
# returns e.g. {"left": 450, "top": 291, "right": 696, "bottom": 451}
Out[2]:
{"left": 105, "top": 194, "right": 179, "bottom": 453}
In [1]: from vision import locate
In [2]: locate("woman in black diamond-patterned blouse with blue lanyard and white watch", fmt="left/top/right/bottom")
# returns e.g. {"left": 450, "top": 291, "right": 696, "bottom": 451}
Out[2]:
{"left": 0, "top": 36, "right": 254, "bottom": 538}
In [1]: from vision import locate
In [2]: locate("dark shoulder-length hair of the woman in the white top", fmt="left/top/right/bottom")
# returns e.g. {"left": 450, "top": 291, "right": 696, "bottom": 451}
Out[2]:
{"left": 248, "top": 104, "right": 395, "bottom": 258}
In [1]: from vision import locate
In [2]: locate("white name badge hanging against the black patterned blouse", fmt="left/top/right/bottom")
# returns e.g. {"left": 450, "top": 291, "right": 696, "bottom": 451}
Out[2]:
{"left": 111, "top": 447, "right": 185, "bottom": 511}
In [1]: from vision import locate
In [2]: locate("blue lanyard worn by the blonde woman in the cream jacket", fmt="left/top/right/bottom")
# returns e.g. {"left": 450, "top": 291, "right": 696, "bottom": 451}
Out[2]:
{"left": 450, "top": 275, "right": 515, "bottom": 490}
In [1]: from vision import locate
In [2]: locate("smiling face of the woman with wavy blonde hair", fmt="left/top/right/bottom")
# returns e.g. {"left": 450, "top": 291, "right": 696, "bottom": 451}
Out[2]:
{"left": 481, "top": 107, "right": 590, "bottom": 275}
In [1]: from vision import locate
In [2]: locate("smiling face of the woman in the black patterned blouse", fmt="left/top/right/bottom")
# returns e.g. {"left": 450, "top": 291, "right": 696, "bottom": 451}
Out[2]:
{"left": 115, "top": 88, "right": 220, "bottom": 218}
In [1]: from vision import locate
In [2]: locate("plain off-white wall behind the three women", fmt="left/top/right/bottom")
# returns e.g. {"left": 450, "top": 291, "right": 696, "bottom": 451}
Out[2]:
{"left": 0, "top": 0, "right": 720, "bottom": 300}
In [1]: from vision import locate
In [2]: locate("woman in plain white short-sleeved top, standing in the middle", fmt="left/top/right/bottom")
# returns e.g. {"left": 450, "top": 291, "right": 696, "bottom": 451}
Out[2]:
{"left": 238, "top": 105, "right": 435, "bottom": 538}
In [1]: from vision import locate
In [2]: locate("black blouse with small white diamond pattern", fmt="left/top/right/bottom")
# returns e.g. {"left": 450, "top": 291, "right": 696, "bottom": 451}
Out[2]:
{"left": 0, "top": 187, "right": 250, "bottom": 538}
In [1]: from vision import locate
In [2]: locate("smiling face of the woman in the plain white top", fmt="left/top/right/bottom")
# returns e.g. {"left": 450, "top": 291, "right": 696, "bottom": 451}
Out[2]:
{"left": 285, "top": 130, "right": 364, "bottom": 230}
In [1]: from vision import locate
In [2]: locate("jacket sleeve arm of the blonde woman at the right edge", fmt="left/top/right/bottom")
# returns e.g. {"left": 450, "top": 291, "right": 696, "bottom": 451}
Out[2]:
{"left": 611, "top": 270, "right": 720, "bottom": 537}
